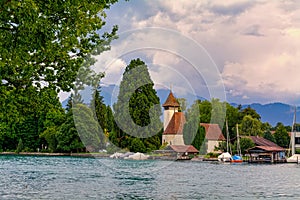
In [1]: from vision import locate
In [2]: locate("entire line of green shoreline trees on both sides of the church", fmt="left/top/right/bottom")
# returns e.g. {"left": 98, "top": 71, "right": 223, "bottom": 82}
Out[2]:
{"left": 0, "top": 55, "right": 291, "bottom": 153}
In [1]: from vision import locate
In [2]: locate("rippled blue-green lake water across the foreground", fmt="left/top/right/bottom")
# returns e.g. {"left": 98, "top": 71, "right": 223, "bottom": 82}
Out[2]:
{"left": 0, "top": 156, "right": 300, "bottom": 200}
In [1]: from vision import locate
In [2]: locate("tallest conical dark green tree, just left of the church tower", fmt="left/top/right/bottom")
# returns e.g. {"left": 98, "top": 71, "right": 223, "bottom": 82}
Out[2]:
{"left": 114, "top": 58, "right": 162, "bottom": 150}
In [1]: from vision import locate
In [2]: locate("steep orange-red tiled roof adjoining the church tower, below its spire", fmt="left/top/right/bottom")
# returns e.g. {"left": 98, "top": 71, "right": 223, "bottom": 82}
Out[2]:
{"left": 163, "top": 112, "right": 185, "bottom": 134}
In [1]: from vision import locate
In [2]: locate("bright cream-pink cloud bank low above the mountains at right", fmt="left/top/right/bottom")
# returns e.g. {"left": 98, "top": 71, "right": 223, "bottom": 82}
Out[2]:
{"left": 222, "top": 51, "right": 300, "bottom": 102}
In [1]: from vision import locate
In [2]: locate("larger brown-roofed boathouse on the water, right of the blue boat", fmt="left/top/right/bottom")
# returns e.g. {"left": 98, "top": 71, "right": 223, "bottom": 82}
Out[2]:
{"left": 246, "top": 136, "right": 286, "bottom": 163}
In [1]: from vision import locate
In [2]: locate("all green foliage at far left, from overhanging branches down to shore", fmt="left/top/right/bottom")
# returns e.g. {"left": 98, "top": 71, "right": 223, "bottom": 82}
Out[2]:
{"left": 0, "top": 0, "right": 117, "bottom": 151}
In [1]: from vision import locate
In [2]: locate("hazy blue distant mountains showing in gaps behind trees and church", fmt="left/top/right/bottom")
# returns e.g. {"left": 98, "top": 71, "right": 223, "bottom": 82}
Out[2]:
{"left": 62, "top": 85, "right": 300, "bottom": 126}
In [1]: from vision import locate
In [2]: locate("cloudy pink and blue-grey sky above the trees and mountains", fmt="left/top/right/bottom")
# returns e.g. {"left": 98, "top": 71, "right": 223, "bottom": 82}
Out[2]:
{"left": 92, "top": 0, "right": 300, "bottom": 105}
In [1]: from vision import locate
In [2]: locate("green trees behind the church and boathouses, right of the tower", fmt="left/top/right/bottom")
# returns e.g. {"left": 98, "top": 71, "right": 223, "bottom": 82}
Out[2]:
{"left": 184, "top": 98, "right": 292, "bottom": 153}
